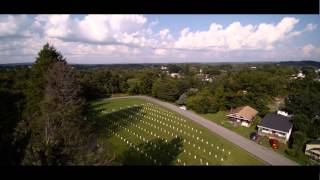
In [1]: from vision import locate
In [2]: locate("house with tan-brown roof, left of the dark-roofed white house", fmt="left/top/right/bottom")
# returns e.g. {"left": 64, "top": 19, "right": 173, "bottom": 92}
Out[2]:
{"left": 227, "top": 106, "right": 258, "bottom": 127}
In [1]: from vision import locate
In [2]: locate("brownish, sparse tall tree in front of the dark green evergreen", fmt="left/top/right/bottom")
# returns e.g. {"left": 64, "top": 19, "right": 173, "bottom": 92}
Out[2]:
{"left": 25, "top": 62, "right": 87, "bottom": 165}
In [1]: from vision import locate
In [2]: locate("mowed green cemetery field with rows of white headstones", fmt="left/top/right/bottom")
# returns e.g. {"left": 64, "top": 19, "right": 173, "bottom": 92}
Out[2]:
{"left": 92, "top": 99, "right": 264, "bottom": 165}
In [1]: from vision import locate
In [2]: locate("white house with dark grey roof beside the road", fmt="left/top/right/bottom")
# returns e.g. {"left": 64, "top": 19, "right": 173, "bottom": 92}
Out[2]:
{"left": 257, "top": 113, "right": 293, "bottom": 143}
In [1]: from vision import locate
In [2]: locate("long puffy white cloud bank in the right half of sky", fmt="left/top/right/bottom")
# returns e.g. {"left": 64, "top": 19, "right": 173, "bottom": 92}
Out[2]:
{"left": 175, "top": 17, "right": 299, "bottom": 51}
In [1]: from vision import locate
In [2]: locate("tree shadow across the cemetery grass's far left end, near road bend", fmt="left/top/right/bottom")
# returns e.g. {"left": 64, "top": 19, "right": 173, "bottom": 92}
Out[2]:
{"left": 88, "top": 106, "right": 144, "bottom": 137}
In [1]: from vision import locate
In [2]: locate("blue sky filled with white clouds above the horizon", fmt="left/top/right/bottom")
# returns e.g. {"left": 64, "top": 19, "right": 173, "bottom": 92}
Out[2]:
{"left": 0, "top": 15, "right": 320, "bottom": 64}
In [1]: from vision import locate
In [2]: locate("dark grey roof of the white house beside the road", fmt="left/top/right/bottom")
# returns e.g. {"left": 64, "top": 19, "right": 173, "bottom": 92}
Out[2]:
{"left": 258, "top": 113, "right": 293, "bottom": 132}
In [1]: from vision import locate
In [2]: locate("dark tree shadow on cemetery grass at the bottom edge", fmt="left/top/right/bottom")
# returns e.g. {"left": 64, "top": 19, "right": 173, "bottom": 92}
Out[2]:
{"left": 122, "top": 137, "right": 183, "bottom": 165}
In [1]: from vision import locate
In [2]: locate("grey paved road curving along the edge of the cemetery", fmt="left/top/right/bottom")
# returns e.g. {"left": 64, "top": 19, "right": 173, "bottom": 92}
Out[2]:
{"left": 111, "top": 96, "right": 298, "bottom": 166}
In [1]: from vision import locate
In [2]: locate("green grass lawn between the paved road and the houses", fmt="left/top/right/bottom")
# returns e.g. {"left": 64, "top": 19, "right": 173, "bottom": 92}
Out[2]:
{"left": 201, "top": 111, "right": 308, "bottom": 165}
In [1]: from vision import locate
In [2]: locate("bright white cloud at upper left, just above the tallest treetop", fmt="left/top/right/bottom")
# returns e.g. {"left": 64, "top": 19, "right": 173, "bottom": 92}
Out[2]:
{"left": 35, "top": 15, "right": 147, "bottom": 44}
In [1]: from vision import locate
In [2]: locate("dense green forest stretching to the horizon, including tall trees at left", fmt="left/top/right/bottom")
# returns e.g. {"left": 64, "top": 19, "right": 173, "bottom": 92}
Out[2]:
{"left": 0, "top": 44, "right": 320, "bottom": 165}
